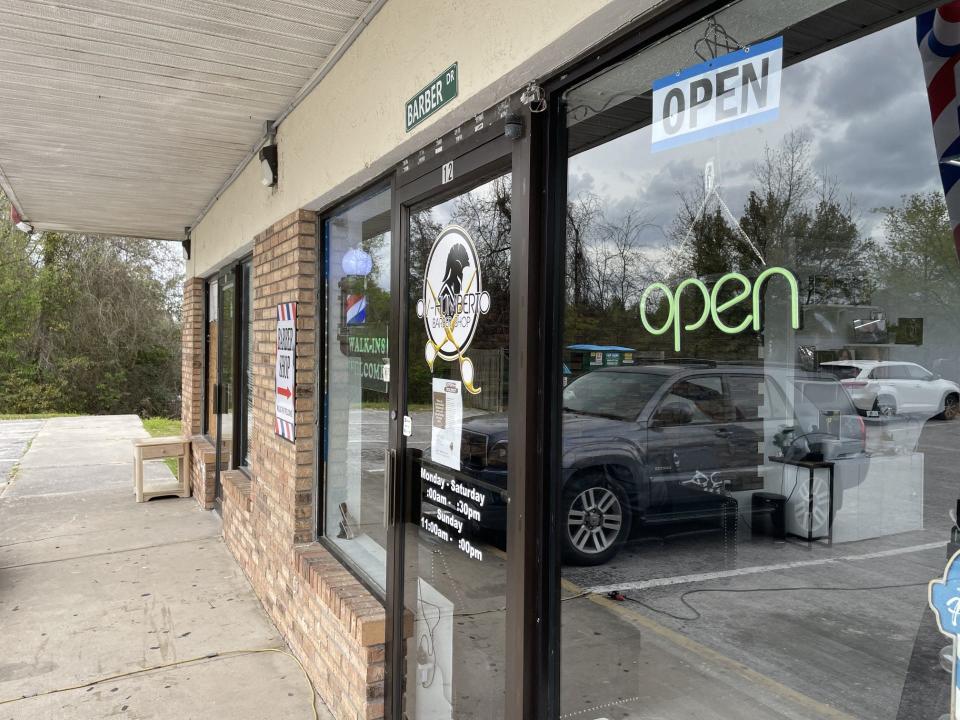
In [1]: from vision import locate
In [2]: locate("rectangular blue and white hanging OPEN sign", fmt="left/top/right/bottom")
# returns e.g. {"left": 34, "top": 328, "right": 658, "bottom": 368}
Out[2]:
{"left": 651, "top": 37, "right": 783, "bottom": 152}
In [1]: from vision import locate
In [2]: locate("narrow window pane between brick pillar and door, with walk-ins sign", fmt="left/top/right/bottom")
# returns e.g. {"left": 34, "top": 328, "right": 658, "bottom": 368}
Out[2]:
{"left": 323, "top": 183, "right": 391, "bottom": 590}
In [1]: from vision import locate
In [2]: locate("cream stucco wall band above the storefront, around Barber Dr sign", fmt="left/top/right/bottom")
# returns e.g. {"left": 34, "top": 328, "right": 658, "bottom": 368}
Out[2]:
{"left": 187, "top": 0, "right": 666, "bottom": 277}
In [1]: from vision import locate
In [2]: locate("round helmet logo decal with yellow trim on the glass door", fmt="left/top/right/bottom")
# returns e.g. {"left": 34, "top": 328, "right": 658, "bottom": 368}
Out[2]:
{"left": 417, "top": 225, "right": 490, "bottom": 395}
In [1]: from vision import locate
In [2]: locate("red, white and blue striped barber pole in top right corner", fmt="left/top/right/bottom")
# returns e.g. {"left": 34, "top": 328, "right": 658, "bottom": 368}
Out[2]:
{"left": 917, "top": 1, "right": 960, "bottom": 256}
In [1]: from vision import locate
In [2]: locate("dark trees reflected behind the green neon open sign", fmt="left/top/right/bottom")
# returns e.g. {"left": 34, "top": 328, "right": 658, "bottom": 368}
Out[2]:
{"left": 566, "top": 129, "right": 892, "bottom": 357}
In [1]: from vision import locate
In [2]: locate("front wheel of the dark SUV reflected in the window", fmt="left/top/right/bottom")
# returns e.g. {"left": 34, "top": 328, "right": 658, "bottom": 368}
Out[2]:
{"left": 563, "top": 470, "right": 630, "bottom": 565}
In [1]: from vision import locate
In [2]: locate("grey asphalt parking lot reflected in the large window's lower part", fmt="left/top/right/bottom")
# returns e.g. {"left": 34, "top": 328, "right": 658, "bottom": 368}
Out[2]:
{"left": 563, "top": 421, "right": 960, "bottom": 720}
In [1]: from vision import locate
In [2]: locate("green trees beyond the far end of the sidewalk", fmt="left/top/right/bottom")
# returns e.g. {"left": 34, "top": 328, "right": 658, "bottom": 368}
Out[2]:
{"left": 0, "top": 191, "right": 182, "bottom": 416}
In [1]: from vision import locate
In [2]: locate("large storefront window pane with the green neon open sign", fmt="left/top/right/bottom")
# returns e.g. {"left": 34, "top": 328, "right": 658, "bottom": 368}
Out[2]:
{"left": 558, "top": 0, "right": 960, "bottom": 720}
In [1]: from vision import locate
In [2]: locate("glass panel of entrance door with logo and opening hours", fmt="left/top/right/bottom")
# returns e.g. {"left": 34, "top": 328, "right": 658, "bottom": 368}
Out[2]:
{"left": 393, "top": 151, "right": 511, "bottom": 720}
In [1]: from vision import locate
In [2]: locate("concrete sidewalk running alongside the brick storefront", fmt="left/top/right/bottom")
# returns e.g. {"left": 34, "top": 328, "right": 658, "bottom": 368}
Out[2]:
{"left": 0, "top": 416, "right": 330, "bottom": 720}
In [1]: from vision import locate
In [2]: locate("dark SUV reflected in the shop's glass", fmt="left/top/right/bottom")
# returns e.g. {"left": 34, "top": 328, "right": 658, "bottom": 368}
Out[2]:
{"left": 462, "top": 362, "right": 866, "bottom": 565}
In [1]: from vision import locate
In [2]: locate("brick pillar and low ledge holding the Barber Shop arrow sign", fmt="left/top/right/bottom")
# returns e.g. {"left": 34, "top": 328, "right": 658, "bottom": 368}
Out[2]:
{"left": 214, "top": 211, "right": 384, "bottom": 720}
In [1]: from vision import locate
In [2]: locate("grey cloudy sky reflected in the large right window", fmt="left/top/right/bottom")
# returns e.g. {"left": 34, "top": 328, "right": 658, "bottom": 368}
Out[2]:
{"left": 568, "top": 20, "right": 940, "bottom": 253}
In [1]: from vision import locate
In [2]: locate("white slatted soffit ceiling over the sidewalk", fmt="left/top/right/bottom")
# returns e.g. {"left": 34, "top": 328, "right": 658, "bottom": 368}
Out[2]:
{"left": 0, "top": 0, "right": 384, "bottom": 240}
